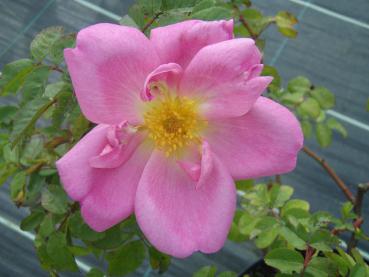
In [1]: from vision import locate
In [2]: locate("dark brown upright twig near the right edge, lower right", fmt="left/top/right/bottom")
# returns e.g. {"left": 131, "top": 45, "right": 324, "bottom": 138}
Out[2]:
{"left": 347, "top": 183, "right": 369, "bottom": 253}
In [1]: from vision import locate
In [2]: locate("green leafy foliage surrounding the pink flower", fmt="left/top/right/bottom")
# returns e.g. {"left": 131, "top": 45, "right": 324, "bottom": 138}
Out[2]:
{"left": 0, "top": 0, "right": 369, "bottom": 277}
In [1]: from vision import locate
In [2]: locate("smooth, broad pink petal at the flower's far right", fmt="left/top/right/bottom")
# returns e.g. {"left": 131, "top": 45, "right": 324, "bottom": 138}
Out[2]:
{"left": 207, "top": 97, "right": 303, "bottom": 179}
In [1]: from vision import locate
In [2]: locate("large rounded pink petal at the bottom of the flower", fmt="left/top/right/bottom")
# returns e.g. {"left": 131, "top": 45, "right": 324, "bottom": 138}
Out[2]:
{"left": 135, "top": 144, "right": 236, "bottom": 258}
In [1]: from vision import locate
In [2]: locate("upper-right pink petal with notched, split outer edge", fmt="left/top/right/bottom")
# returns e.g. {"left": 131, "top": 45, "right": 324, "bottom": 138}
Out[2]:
{"left": 179, "top": 38, "right": 272, "bottom": 119}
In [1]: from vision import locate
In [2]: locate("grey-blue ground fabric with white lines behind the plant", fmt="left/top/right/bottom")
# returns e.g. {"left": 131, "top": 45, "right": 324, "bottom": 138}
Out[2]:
{"left": 0, "top": 0, "right": 369, "bottom": 276}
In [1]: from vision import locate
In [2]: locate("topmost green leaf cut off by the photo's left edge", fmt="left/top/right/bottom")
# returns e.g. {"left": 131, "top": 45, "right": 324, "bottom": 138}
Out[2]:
{"left": 0, "top": 59, "right": 35, "bottom": 95}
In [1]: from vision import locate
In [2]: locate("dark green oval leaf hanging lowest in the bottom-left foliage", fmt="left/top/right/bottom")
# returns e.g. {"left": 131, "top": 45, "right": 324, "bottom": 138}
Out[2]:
{"left": 46, "top": 232, "right": 78, "bottom": 271}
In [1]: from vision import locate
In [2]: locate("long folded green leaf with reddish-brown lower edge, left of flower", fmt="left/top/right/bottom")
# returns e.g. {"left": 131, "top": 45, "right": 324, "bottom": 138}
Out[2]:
{"left": 12, "top": 98, "right": 55, "bottom": 148}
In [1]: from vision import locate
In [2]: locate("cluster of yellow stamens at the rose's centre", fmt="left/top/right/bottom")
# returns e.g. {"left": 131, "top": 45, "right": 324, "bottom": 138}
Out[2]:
{"left": 144, "top": 91, "right": 206, "bottom": 156}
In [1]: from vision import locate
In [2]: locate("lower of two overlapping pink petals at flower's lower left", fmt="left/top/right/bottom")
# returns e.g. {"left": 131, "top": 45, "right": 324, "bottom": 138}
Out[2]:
{"left": 81, "top": 140, "right": 151, "bottom": 232}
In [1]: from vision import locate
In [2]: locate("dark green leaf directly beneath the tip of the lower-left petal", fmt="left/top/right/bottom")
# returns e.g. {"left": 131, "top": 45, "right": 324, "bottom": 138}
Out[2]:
{"left": 68, "top": 212, "right": 105, "bottom": 241}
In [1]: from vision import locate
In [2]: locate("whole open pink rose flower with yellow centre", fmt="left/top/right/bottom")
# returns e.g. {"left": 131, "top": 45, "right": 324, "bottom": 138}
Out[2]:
{"left": 56, "top": 20, "right": 303, "bottom": 257}
